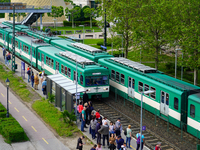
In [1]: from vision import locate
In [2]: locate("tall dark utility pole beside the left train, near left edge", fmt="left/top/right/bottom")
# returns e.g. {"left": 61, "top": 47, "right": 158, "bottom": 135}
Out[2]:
{"left": 12, "top": 4, "right": 15, "bottom": 72}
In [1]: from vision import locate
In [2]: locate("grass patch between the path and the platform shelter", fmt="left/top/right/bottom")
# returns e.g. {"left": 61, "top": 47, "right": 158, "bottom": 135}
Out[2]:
{"left": 32, "top": 100, "right": 79, "bottom": 136}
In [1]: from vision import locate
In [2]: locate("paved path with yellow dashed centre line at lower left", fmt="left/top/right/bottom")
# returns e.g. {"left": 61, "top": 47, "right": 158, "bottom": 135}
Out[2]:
{"left": 0, "top": 49, "right": 69, "bottom": 150}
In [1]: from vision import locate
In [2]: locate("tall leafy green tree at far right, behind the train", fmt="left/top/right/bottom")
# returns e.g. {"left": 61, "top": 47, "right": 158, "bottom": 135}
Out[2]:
{"left": 173, "top": 0, "right": 200, "bottom": 85}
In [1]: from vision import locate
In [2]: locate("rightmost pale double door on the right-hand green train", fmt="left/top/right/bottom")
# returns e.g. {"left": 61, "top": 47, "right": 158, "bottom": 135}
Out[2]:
{"left": 160, "top": 91, "right": 169, "bottom": 116}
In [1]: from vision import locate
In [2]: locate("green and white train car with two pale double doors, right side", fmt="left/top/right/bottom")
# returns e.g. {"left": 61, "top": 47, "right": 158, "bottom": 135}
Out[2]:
{"left": 99, "top": 57, "right": 200, "bottom": 135}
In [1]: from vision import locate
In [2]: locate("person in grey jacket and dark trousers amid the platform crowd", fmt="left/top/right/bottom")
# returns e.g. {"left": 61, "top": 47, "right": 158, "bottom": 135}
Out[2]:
{"left": 98, "top": 122, "right": 109, "bottom": 148}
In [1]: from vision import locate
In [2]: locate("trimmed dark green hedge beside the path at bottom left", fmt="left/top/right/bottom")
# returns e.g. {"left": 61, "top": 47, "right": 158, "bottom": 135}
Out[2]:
{"left": 0, "top": 103, "right": 28, "bottom": 143}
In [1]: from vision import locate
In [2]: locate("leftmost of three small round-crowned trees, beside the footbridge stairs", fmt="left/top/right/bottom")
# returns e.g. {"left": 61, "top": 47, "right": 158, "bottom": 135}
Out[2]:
{"left": 47, "top": 6, "right": 64, "bottom": 28}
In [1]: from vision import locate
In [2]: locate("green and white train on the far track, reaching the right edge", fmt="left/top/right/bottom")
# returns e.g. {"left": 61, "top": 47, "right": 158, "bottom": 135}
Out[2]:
{"left": 0, "top": 22, "right": 200, "bottom": 138}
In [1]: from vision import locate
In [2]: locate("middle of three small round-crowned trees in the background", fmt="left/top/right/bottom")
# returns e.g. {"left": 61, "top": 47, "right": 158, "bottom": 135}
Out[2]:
{"left": 65, "top": 6, "right": 81, "bottom": 28}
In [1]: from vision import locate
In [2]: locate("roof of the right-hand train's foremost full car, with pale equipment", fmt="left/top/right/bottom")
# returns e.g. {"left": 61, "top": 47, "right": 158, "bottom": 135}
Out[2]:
{"left": 100, "top": 57, "right": 200, "bottom": 91}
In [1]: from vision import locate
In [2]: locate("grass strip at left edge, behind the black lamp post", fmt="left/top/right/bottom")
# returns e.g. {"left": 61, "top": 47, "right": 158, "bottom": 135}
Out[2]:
{"left": 0, "top": 65, "right": 33, "bottom": 102}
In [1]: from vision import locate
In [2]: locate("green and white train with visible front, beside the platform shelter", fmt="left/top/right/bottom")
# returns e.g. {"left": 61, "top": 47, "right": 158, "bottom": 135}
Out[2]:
{"left": 0, "top": 26, "right": 109, "bottom": 99}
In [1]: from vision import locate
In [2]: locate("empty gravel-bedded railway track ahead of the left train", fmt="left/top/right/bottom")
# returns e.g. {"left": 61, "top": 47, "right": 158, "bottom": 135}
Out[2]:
{"left": 93, "top": 94, "right": 198, "bottom": 150}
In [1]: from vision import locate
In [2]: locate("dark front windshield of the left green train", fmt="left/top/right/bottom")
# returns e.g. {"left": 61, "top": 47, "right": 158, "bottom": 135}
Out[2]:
{"left": 85, "top": 76, "right": 108, "bottom": 86}
